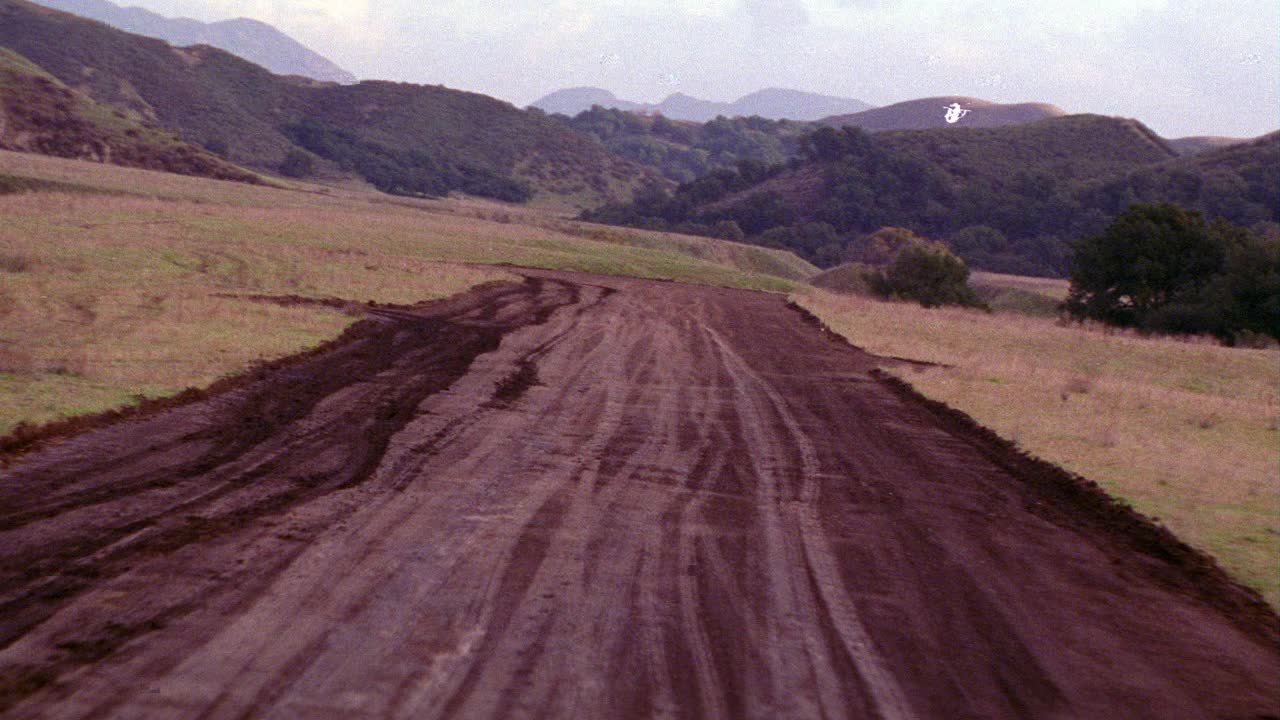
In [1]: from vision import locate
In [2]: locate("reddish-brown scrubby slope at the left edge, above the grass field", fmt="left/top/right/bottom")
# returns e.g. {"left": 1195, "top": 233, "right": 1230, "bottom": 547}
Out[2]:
{"left": 0, "top": 47, "right": 260, "bottom": 183}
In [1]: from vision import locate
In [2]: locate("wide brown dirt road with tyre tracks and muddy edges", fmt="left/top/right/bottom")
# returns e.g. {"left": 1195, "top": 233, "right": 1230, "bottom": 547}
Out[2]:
{"left": 0, "top": 273, "right": 1280, "bottom": 720}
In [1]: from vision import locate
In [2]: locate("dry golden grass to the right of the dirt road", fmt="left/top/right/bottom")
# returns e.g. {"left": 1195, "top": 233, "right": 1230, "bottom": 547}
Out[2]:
{"left": 796, "top": 285, "right": 1280, "bottom": 606}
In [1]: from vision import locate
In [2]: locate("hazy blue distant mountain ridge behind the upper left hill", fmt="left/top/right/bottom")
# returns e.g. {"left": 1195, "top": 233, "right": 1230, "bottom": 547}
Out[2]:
{"left": 31, "top": 0, "right": 356, "bottom": 83}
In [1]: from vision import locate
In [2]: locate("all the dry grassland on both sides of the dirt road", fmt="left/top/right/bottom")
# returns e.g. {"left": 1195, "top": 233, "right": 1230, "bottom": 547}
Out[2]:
{"left": 0, "top": 152, "right": 1280, "bottom": 606}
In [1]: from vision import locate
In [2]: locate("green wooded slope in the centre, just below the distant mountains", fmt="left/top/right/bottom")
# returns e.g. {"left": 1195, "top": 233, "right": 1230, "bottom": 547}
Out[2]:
{"left": 552, "top": 105, "right": 813, "bottom": 182}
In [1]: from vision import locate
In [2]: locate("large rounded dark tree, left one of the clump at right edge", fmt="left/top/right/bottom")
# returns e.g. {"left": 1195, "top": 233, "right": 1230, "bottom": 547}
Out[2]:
{"left": 1066, "top": 202, "right": 1225, "bottom": 327}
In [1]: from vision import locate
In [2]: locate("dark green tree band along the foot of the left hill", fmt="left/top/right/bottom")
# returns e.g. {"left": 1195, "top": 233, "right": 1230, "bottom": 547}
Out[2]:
{"left": 280, "top": 119, "right": 534, "bottom": 202}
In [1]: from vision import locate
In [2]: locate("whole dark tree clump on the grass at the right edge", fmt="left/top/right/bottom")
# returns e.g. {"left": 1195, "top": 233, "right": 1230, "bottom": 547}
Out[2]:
{"left": 1065, "top": 202, "right": 1280, "bottom": 343}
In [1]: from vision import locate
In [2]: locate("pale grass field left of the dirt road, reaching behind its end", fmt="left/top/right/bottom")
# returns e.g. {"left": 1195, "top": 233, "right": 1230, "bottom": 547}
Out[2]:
{"left": 0, "top": 152, "right": 806, "bottom": 434}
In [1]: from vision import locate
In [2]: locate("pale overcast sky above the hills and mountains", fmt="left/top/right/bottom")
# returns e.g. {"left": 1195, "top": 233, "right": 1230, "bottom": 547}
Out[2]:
{"left": 116, "top": 0, "right": 1280, "bottom": 137}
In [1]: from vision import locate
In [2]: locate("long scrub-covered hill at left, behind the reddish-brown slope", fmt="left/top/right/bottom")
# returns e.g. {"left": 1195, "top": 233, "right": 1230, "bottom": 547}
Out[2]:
{"left": 0, "top": 0, "right": 648, "bottom": 206}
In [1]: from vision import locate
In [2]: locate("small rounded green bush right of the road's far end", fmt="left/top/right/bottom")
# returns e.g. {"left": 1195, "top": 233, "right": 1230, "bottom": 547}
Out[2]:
{"left": 867, "top": 242, "right": 983, "bottom": 307}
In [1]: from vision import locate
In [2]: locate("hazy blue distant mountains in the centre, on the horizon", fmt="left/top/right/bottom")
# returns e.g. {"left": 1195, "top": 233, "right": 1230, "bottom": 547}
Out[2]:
{"left": 532, "top": 87, "right": 872, "bottom": 123}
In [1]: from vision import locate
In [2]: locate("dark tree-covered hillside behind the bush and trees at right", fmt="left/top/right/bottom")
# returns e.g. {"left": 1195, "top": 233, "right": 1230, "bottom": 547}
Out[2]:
{"left": 585, "top": 117, "right": 1280, "bottom": 277}
